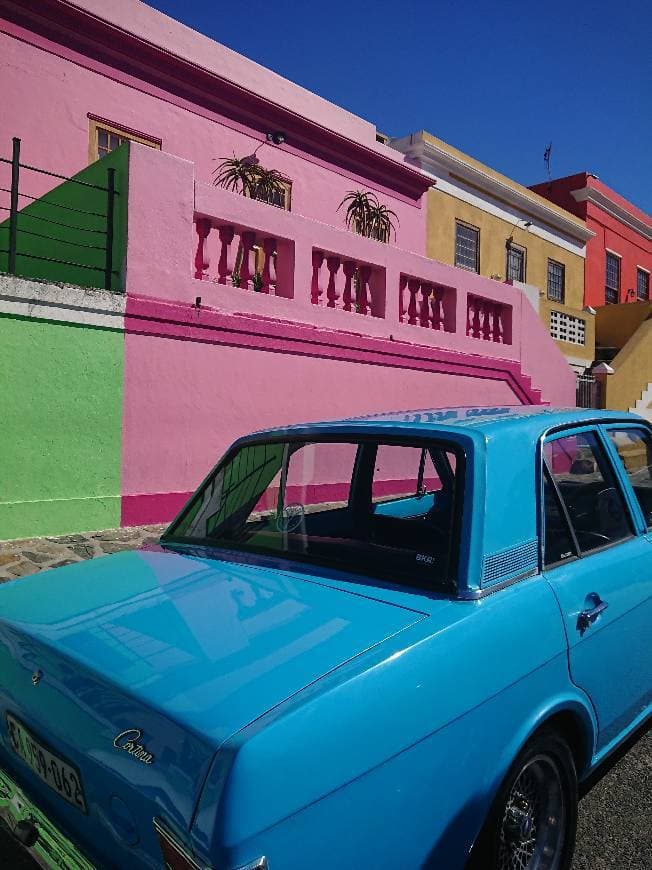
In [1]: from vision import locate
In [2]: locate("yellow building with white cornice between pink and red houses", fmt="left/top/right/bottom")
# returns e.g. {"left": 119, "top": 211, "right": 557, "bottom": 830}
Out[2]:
{"left": 391, "top": 131, "right": 595, "bottom": 373}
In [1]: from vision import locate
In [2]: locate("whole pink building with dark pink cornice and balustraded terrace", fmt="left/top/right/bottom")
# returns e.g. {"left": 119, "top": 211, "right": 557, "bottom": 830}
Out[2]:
{"left": 0, "top": 0, "right": 575, "bottom": 538}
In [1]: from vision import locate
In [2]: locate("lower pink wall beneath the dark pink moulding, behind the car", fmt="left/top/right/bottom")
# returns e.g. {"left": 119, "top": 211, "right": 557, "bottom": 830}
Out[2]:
{"left": 122, "top": 324, "right": 518, "bottom": 523}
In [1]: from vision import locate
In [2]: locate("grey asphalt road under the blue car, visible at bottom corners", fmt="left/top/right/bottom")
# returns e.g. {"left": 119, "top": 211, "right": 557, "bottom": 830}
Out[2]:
{"left": 0, "top": 731, "right": 652, "bottom": 870}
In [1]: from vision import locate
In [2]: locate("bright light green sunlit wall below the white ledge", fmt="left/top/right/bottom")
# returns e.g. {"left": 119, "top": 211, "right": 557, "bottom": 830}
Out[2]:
{"left": 0, "top": 314, "right": 124, "bottom": 540}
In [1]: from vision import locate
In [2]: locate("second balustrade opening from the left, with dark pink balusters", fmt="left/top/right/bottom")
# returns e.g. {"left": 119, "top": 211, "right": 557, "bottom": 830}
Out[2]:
{"left": 310, "top": 250, "right": 385, "bottom": 317}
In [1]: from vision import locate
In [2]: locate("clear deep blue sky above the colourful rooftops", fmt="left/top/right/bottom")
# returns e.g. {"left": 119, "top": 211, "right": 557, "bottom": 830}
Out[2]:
{"left": 150, "top": 0, "right": 652, "bottom": 213}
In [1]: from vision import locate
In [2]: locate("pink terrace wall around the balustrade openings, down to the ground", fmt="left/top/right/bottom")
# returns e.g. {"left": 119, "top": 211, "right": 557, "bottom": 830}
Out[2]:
{"left": 122, "top": 145, "right": 574, "bottom": 523}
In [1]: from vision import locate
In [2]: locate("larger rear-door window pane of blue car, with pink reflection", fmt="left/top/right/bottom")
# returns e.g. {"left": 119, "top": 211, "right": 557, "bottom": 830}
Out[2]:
{"left": 544, "top": 432, "right": 632, "bottom": 553}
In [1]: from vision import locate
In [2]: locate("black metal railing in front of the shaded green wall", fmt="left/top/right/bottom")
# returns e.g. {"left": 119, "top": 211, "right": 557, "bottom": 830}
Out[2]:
{"left": 0, "top": 137, "right": 118, "bottom": 290}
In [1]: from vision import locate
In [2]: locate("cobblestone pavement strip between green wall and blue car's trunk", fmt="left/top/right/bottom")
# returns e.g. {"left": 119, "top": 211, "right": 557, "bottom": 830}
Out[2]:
{"left": 0, "top": 526, "right": 165, "bottom": 583}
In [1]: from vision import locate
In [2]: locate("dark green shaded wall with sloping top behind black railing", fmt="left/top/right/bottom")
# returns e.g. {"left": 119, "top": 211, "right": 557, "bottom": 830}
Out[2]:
{"left": 0, "top": 142, "right": 129, "bottom": 292}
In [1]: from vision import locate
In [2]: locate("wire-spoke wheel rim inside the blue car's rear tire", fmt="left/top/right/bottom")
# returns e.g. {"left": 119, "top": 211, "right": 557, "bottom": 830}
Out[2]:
{"left": 498, "top": 755, "right": 566, "bottom": 870}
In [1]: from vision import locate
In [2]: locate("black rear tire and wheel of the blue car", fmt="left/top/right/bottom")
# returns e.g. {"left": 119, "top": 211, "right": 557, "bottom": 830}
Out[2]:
{"left": 467, "top": 730, "right": 578, "bottom": 870}
